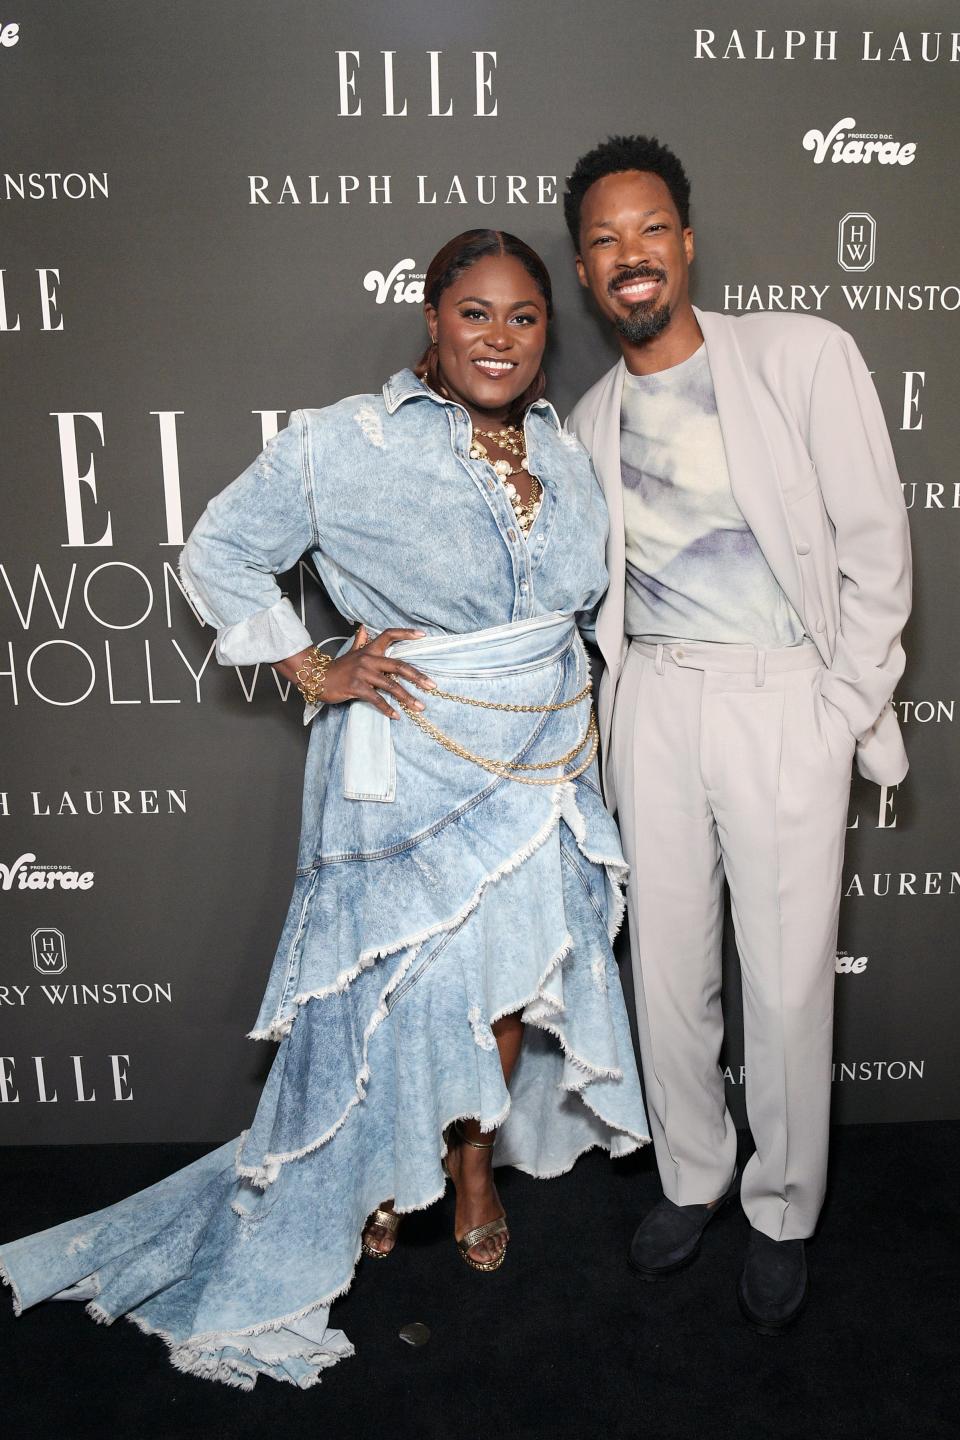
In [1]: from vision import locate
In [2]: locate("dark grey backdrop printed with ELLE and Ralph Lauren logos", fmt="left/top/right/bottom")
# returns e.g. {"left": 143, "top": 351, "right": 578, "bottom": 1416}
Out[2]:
{"left": 0, "top": 0, "right": 960, "bottom": 1145}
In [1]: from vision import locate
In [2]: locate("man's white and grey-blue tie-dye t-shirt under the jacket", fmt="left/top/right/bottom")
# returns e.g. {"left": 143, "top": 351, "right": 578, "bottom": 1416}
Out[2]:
{"left": 620, "top": 346, "right": 803, "bottom": 648}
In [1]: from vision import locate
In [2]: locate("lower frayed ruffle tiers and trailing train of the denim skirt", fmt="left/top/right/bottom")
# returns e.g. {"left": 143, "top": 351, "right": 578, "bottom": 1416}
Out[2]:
{"left": 0, "top": 760, "right": 649, "bottom": 1390}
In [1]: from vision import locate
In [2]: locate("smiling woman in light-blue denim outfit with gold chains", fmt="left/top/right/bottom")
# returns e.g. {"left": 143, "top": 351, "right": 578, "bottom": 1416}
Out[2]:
{"left": 0, "top": 230, "right": 646, "bottom": 1390}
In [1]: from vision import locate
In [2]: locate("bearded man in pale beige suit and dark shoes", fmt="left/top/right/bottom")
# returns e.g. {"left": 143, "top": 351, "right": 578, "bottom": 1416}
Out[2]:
{"left": 564, "top": 137, "right": 910, "bottom": 1333}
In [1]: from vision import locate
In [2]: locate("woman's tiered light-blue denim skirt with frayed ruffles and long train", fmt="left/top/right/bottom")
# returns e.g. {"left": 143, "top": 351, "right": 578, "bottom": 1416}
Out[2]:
{"left": 0, "top": 624, "right": 648, "bottom": 1390}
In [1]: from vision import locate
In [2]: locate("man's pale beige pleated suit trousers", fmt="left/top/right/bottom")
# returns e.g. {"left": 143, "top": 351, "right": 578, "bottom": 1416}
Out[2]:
{"left": 607, "top": 641, "right": 853, "bottom": 1240}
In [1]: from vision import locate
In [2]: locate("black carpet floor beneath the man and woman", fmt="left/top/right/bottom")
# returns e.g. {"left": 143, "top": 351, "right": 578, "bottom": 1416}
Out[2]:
{"left": 0, "top": 1123, "right": 960, "bottom": 1440}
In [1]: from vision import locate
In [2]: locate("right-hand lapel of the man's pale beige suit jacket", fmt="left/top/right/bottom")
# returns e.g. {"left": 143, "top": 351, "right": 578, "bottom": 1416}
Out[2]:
{"left": 694, "top": 307, "right": 803, "bottom": 613}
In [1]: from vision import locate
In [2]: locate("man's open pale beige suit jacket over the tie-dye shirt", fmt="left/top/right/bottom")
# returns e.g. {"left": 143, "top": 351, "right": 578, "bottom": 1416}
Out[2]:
{"left": 567, "top": 310, "right": 911, "bottom": 805}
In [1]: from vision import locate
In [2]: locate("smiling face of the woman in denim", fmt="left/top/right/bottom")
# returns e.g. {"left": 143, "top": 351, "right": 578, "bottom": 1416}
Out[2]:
{"left": 425, "top": 255, "right": 547, "bottom": 425}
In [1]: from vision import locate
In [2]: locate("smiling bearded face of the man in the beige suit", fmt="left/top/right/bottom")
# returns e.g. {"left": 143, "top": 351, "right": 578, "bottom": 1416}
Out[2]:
{"left": 577, "top": 170, "right": 694, "bottom": 346}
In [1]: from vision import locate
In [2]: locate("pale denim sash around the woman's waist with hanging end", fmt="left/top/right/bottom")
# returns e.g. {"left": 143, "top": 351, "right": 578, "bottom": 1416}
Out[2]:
{"left": 344, "top": 613, "right": 577, "bottom": 801}
